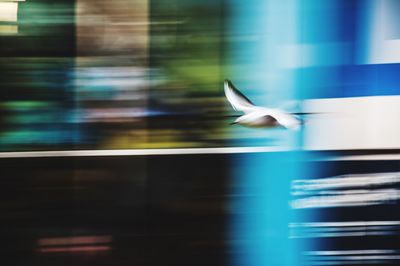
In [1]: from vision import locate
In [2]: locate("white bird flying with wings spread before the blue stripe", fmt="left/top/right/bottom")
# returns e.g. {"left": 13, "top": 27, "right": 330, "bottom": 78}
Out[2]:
{"left": 224, "top": 79, "right": 302, "bottom": 130}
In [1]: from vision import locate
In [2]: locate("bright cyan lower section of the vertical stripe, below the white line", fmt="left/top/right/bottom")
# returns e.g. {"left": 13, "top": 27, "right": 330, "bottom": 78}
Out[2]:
{"left": 231, "top": 153, "right": 299, "bottom": 266}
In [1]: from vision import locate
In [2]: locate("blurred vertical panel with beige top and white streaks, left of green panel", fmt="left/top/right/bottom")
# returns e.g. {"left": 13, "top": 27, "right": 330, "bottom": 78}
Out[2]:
{"left": 74, "top": 0, "right": 150, "bottom": 148}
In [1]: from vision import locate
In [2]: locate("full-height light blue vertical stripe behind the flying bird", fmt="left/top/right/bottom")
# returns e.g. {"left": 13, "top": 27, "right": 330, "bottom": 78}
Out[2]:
{"left": 227, "top": 0, "right": 306, "bottom": 266}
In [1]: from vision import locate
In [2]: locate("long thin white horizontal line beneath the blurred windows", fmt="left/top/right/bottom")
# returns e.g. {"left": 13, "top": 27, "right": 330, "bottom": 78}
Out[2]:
{"left": 0, "top": 147, "right": 290, "bottom": 158}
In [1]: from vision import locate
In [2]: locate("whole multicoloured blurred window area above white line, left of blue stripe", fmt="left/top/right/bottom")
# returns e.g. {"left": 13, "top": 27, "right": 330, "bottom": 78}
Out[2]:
{"left": 0, "top": 0, "right": 233, "bottom": 151}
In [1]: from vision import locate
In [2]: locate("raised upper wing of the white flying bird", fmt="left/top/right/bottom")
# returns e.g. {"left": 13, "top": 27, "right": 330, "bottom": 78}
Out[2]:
{"left": 224, "top": 80, "right": 258, "bottom": 113}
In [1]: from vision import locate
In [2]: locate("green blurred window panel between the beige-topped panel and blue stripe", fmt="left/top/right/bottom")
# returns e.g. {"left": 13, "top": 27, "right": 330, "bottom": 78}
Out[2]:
{"left": 145, "top": 0, "right": 227, "bottom": 149}
